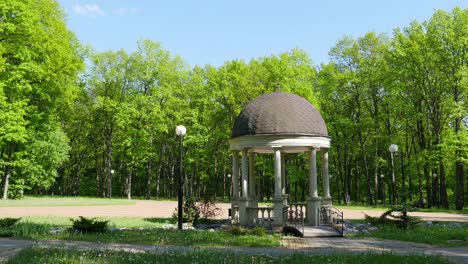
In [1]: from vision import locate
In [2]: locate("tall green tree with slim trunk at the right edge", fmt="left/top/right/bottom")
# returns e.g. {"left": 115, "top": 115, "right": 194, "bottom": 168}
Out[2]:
{"left": 425, "top": 8, "right": 468, "bottom": 210}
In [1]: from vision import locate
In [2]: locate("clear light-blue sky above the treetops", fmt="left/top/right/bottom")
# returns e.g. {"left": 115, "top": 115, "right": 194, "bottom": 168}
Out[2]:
{"left": 58, "top": 0, "right": 467, "bottom": 66}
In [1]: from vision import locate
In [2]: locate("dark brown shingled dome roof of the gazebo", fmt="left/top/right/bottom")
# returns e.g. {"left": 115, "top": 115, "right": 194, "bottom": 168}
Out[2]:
{"left": 232, "top": 92, "right": 328, "bottom": 138}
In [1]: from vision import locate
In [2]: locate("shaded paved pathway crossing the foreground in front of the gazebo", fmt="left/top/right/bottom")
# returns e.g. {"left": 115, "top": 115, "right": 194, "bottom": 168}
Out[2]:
{"left": 0, "top": 237, "right": 468, "bottom": 264}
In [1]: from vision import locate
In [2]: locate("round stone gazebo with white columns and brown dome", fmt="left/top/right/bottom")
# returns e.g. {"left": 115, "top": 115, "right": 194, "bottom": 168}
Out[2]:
{"left": 229, "top": 91, "right": 332, "bottom": 226}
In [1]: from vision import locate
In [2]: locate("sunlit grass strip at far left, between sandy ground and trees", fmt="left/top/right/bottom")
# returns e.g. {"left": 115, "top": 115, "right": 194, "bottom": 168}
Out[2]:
{"left": 0, "top": 196, "right": 136, "bottom": 207}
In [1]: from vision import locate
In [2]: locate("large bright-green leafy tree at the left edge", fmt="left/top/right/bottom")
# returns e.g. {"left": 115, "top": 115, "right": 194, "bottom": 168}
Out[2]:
{"left": 0, "top": 0, "right": 83, "bottom": 199}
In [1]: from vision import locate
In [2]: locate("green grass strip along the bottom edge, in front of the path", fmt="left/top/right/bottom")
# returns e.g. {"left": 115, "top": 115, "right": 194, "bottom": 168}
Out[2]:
{"left": 7, "top": 247, "right": 452, "bottom": 264}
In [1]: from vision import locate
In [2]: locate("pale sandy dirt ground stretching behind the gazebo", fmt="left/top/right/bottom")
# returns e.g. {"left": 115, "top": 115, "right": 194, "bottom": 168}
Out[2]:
{"left": 0, "top": 200, "right": 468, "bottom": 222}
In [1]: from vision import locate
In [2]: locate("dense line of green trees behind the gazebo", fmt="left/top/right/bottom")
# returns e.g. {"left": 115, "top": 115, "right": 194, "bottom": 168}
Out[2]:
{"left": 0, "top": 0, "right": 468, "bottom": 209}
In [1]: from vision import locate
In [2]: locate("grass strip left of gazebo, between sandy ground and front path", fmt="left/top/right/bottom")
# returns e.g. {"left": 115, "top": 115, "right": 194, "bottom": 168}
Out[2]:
{"left": 0, "top": 217, "right": 281, "bottom": 247}
